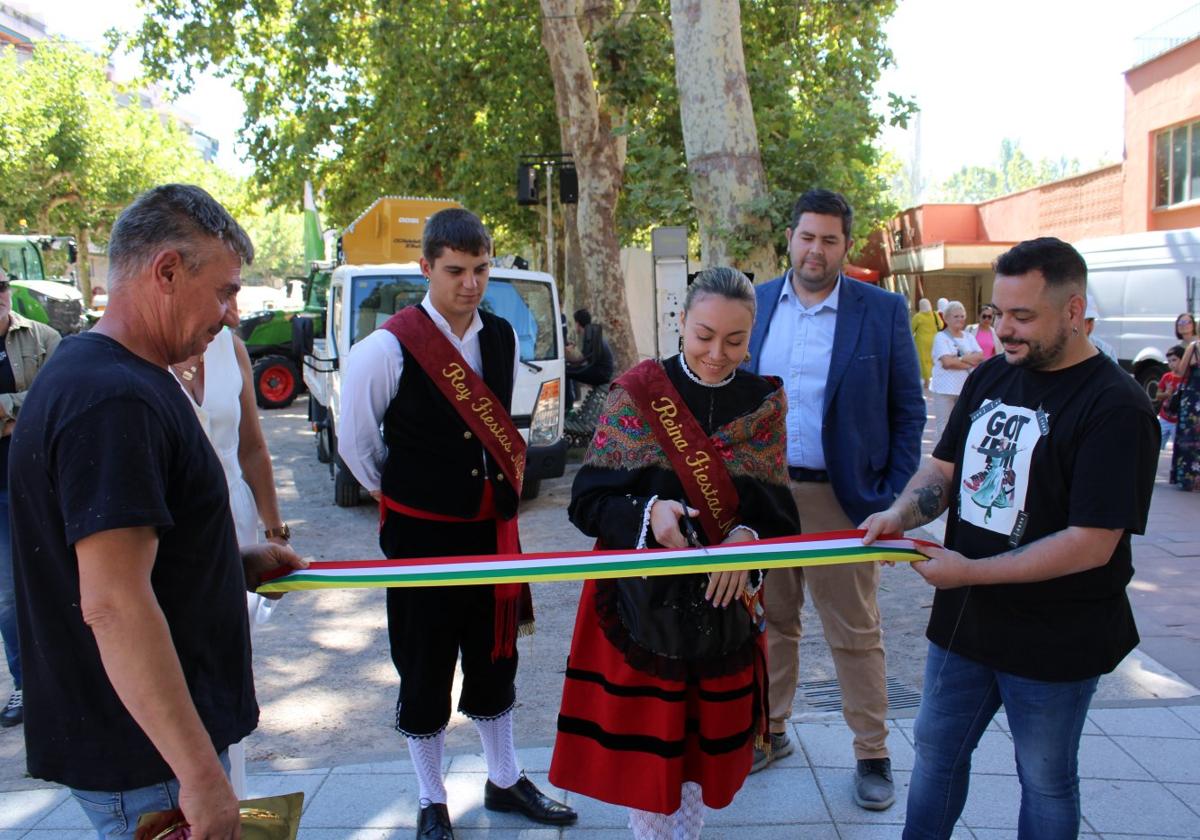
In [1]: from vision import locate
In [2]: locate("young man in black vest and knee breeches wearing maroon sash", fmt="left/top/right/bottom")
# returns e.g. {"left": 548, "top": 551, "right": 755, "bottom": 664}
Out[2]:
{"left": 338, "top": 209, "right": 576, "bottom": 840}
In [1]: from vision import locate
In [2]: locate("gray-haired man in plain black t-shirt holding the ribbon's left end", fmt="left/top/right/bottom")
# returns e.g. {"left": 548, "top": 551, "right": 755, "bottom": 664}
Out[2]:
{"left": 10, "top": 185, "right": 304, "bottom": 839}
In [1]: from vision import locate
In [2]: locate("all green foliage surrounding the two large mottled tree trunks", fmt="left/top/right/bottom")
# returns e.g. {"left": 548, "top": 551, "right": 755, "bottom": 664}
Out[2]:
{"left": 126, "top": 0, "right": 912, "bottom": 262}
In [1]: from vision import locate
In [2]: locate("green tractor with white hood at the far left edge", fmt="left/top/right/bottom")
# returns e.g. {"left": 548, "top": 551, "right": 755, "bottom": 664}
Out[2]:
{"left": 0, "top": 234, "right": 88, "bottom": 335}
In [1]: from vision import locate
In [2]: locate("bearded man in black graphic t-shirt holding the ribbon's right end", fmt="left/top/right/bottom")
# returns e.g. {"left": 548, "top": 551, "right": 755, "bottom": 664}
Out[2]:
{"left": 863, "top": 238, "right": 1159, "bottom": 840}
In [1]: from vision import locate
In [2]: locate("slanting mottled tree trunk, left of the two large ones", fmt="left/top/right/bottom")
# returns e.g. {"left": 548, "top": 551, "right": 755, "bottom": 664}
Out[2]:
{"left": 541, "top": 0, "right": 637, "bottom": 370}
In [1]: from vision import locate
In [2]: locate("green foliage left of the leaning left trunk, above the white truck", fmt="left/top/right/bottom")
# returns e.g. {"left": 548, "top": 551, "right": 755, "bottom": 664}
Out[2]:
{"left": 136, "top": 0, "right": 559, "bottom": 249}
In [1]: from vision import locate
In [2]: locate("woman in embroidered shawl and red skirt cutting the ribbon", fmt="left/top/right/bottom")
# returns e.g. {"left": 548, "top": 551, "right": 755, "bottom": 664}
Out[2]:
{"left": 550, "top": 268, "right": 799, "bottom": 840}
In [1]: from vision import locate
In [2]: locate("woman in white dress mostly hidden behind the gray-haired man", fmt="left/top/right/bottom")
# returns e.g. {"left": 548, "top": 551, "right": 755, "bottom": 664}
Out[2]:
{"left": 172, "top": 328, "right": 292, "bottom": 798}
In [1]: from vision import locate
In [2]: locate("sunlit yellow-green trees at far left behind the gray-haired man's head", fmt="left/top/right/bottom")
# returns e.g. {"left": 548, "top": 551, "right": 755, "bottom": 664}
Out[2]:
{"left": 0, "top": 41, "right": 314, "bottom": 295}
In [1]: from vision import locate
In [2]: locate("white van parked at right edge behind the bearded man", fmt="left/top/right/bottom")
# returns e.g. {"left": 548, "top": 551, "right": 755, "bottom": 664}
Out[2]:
{"left": 1075, "top": 228, "right": 1200, "bottom": 397}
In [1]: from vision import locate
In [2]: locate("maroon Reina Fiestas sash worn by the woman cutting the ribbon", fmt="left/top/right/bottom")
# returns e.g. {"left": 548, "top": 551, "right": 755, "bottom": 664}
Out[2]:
{"left": 616, "top": 360, "right": 740, "bottom": 545}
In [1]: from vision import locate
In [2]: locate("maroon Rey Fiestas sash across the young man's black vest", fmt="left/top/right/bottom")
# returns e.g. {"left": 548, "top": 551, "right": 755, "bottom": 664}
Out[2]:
{"left": 380, "top": 306, "right": 526, "bottom": 497}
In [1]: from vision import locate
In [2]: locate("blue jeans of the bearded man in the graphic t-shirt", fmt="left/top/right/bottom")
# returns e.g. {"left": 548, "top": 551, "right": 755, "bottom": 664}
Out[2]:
{"left": 904, "top": 644, "right": 1099, "bottom": 840}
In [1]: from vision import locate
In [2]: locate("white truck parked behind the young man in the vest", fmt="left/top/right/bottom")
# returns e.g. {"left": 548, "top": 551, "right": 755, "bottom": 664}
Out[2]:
{"left": 299, "top": 263, "right": 566, "bottom": 508}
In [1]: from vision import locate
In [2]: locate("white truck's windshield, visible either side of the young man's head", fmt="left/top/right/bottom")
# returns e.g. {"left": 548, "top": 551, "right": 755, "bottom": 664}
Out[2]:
{"left": 348, "top": 274, "right": 558, "bottom": 361}
